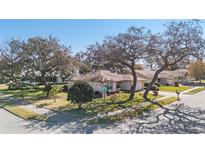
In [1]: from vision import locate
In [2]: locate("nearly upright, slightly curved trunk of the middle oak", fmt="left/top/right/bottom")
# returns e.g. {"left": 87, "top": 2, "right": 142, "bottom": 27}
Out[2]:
{"left": 128, "top": 61, "right": 137, "bottom": 101}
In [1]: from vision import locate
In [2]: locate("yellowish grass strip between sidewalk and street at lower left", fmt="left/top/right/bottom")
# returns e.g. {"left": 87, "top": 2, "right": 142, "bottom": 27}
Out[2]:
{"left": 0, "top": 100, "right": 46, "bottom": 120}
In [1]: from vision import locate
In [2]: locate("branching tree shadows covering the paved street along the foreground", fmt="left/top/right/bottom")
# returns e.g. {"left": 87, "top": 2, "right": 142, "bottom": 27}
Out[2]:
{"left": 21, "top": 101, "right": 205, "bottom": 134}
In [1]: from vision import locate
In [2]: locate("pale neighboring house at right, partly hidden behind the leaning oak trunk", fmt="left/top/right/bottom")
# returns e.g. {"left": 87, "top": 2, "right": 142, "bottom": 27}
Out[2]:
{"left": 136, "top": 69, "right": 190, "bottom": 85}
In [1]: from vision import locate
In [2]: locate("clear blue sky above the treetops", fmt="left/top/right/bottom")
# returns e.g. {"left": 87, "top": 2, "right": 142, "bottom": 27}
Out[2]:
{"left": 0, "top": 19, "right": 205, "bottom": 53}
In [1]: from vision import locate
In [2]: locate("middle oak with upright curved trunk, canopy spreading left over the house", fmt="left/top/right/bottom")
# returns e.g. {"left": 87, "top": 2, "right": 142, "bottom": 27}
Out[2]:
{"left": 81, "top": 27, "right": 149, "bottom": 100}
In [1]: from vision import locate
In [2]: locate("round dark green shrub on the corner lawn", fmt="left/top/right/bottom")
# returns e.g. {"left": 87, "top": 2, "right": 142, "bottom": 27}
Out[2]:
{"left": 68, "top": 81, "right": 93, "bottom": 108}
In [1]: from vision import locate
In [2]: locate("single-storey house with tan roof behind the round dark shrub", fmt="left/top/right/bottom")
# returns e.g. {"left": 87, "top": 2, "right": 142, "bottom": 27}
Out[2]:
{"left": 68, "top": 70, "right": 144, "bottom": 92}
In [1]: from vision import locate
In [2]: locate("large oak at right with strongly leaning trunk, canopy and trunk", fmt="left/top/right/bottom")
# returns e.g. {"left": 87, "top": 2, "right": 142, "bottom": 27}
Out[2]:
{"left": 144, "top": 20, "right": 205, "bottom": 101}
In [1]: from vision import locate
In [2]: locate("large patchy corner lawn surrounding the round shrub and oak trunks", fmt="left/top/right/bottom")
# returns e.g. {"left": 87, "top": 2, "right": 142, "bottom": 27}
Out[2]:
{"left": 0, "top": 85, "right": 166, "bottom": 118}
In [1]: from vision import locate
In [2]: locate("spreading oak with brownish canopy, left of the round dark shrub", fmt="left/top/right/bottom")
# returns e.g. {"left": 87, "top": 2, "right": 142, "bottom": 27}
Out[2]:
{"left": 23, "top": 36, "right": 75, "bottom": 96}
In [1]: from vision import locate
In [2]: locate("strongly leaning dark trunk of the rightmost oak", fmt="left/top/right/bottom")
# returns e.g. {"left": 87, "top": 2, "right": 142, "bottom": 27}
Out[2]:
{"left": 143, "top": 66, "right": 165, "bottom": 101}
